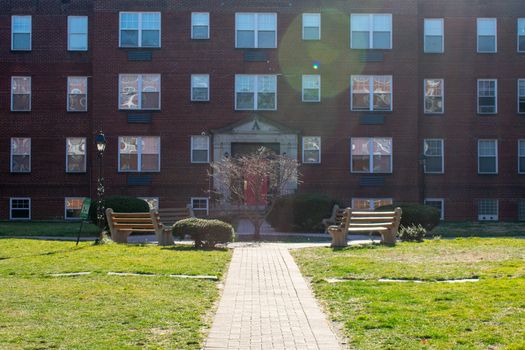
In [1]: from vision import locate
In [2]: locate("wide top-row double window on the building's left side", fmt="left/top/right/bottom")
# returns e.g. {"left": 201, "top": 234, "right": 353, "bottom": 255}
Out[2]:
{"left": 119, "top": 12, "right": 160, "bottom": 47}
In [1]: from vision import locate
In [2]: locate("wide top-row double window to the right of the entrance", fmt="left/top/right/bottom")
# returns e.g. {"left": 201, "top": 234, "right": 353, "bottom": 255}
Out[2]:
{"left": 350, "top": 14, "right": 392, "bottom": 49}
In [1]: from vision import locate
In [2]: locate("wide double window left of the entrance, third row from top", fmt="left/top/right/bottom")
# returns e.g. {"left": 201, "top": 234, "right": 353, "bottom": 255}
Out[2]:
{"left": 118, "top": 136, "right": 160, "bottom": 172}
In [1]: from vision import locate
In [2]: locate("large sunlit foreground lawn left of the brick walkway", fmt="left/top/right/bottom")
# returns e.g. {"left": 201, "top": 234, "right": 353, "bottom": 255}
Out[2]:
{"left": 0, "top": 239, "right": 231, "bottom": 349}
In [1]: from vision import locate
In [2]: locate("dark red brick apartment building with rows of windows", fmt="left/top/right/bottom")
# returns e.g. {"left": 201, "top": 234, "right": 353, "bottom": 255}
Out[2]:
{"left": 0, "top": 0, "right": 525, "bottom": 221}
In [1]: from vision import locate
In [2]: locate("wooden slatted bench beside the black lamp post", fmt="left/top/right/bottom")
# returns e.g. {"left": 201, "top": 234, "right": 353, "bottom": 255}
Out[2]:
{"left": 106, "top": 208, "right": 174, "bottom": 245}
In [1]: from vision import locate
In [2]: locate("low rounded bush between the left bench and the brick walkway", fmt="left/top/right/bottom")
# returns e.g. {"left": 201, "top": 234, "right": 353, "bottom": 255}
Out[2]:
{"left": 173, "top": 218, "right": 233, "bottom": 248}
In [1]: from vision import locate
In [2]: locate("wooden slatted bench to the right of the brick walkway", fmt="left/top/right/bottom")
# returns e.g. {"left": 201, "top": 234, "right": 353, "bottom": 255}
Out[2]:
{"left": 328, "top": 208, "right": 402, "bottom": 247}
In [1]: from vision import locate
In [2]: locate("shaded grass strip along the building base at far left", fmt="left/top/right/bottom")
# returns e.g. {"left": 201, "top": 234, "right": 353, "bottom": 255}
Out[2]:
{"left": 0, "top": 221, "right": 100, "bottom": 237}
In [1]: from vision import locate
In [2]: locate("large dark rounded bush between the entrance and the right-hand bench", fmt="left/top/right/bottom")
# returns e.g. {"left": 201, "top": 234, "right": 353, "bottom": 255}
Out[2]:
{"left": 267, "top": 193, "right": 337, "bottom": 232}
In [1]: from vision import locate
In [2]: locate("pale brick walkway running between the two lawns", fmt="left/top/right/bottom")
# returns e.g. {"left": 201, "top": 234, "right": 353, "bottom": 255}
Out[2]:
{"left": 205, "top": 245, "right": 341, "bottom": 350}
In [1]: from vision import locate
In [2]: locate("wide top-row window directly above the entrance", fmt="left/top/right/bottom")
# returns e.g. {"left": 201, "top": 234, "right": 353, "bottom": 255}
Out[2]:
{"left": 235, "top": 13, "right": 277, "bottom": 49}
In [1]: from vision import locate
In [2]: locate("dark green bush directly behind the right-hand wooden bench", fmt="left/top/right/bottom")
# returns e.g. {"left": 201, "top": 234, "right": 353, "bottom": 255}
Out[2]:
{"left": 376, "top": 203, "right": 440, "bottom": 231}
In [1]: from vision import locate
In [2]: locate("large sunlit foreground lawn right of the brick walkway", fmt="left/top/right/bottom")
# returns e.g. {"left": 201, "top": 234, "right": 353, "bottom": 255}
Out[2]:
{"left": 293, "top": 238, "right": 525, "bottom": 350}
